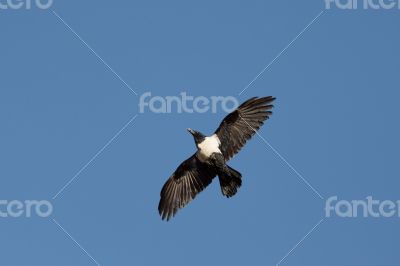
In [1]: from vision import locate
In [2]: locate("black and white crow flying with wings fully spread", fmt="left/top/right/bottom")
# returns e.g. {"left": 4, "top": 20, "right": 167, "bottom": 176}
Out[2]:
{"left": 158, "top": 96, "right": 275, "bottom": 220}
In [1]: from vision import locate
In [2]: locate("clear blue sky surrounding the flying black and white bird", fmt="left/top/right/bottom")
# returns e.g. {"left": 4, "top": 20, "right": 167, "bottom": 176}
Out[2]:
{"left": 0, "top": 0, "right": 400, "bottom": 266}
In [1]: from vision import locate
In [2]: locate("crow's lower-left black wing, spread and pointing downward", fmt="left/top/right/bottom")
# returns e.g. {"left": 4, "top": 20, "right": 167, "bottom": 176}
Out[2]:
{"left": 158, "top": 154, "right": 216, "bottom": 221}
